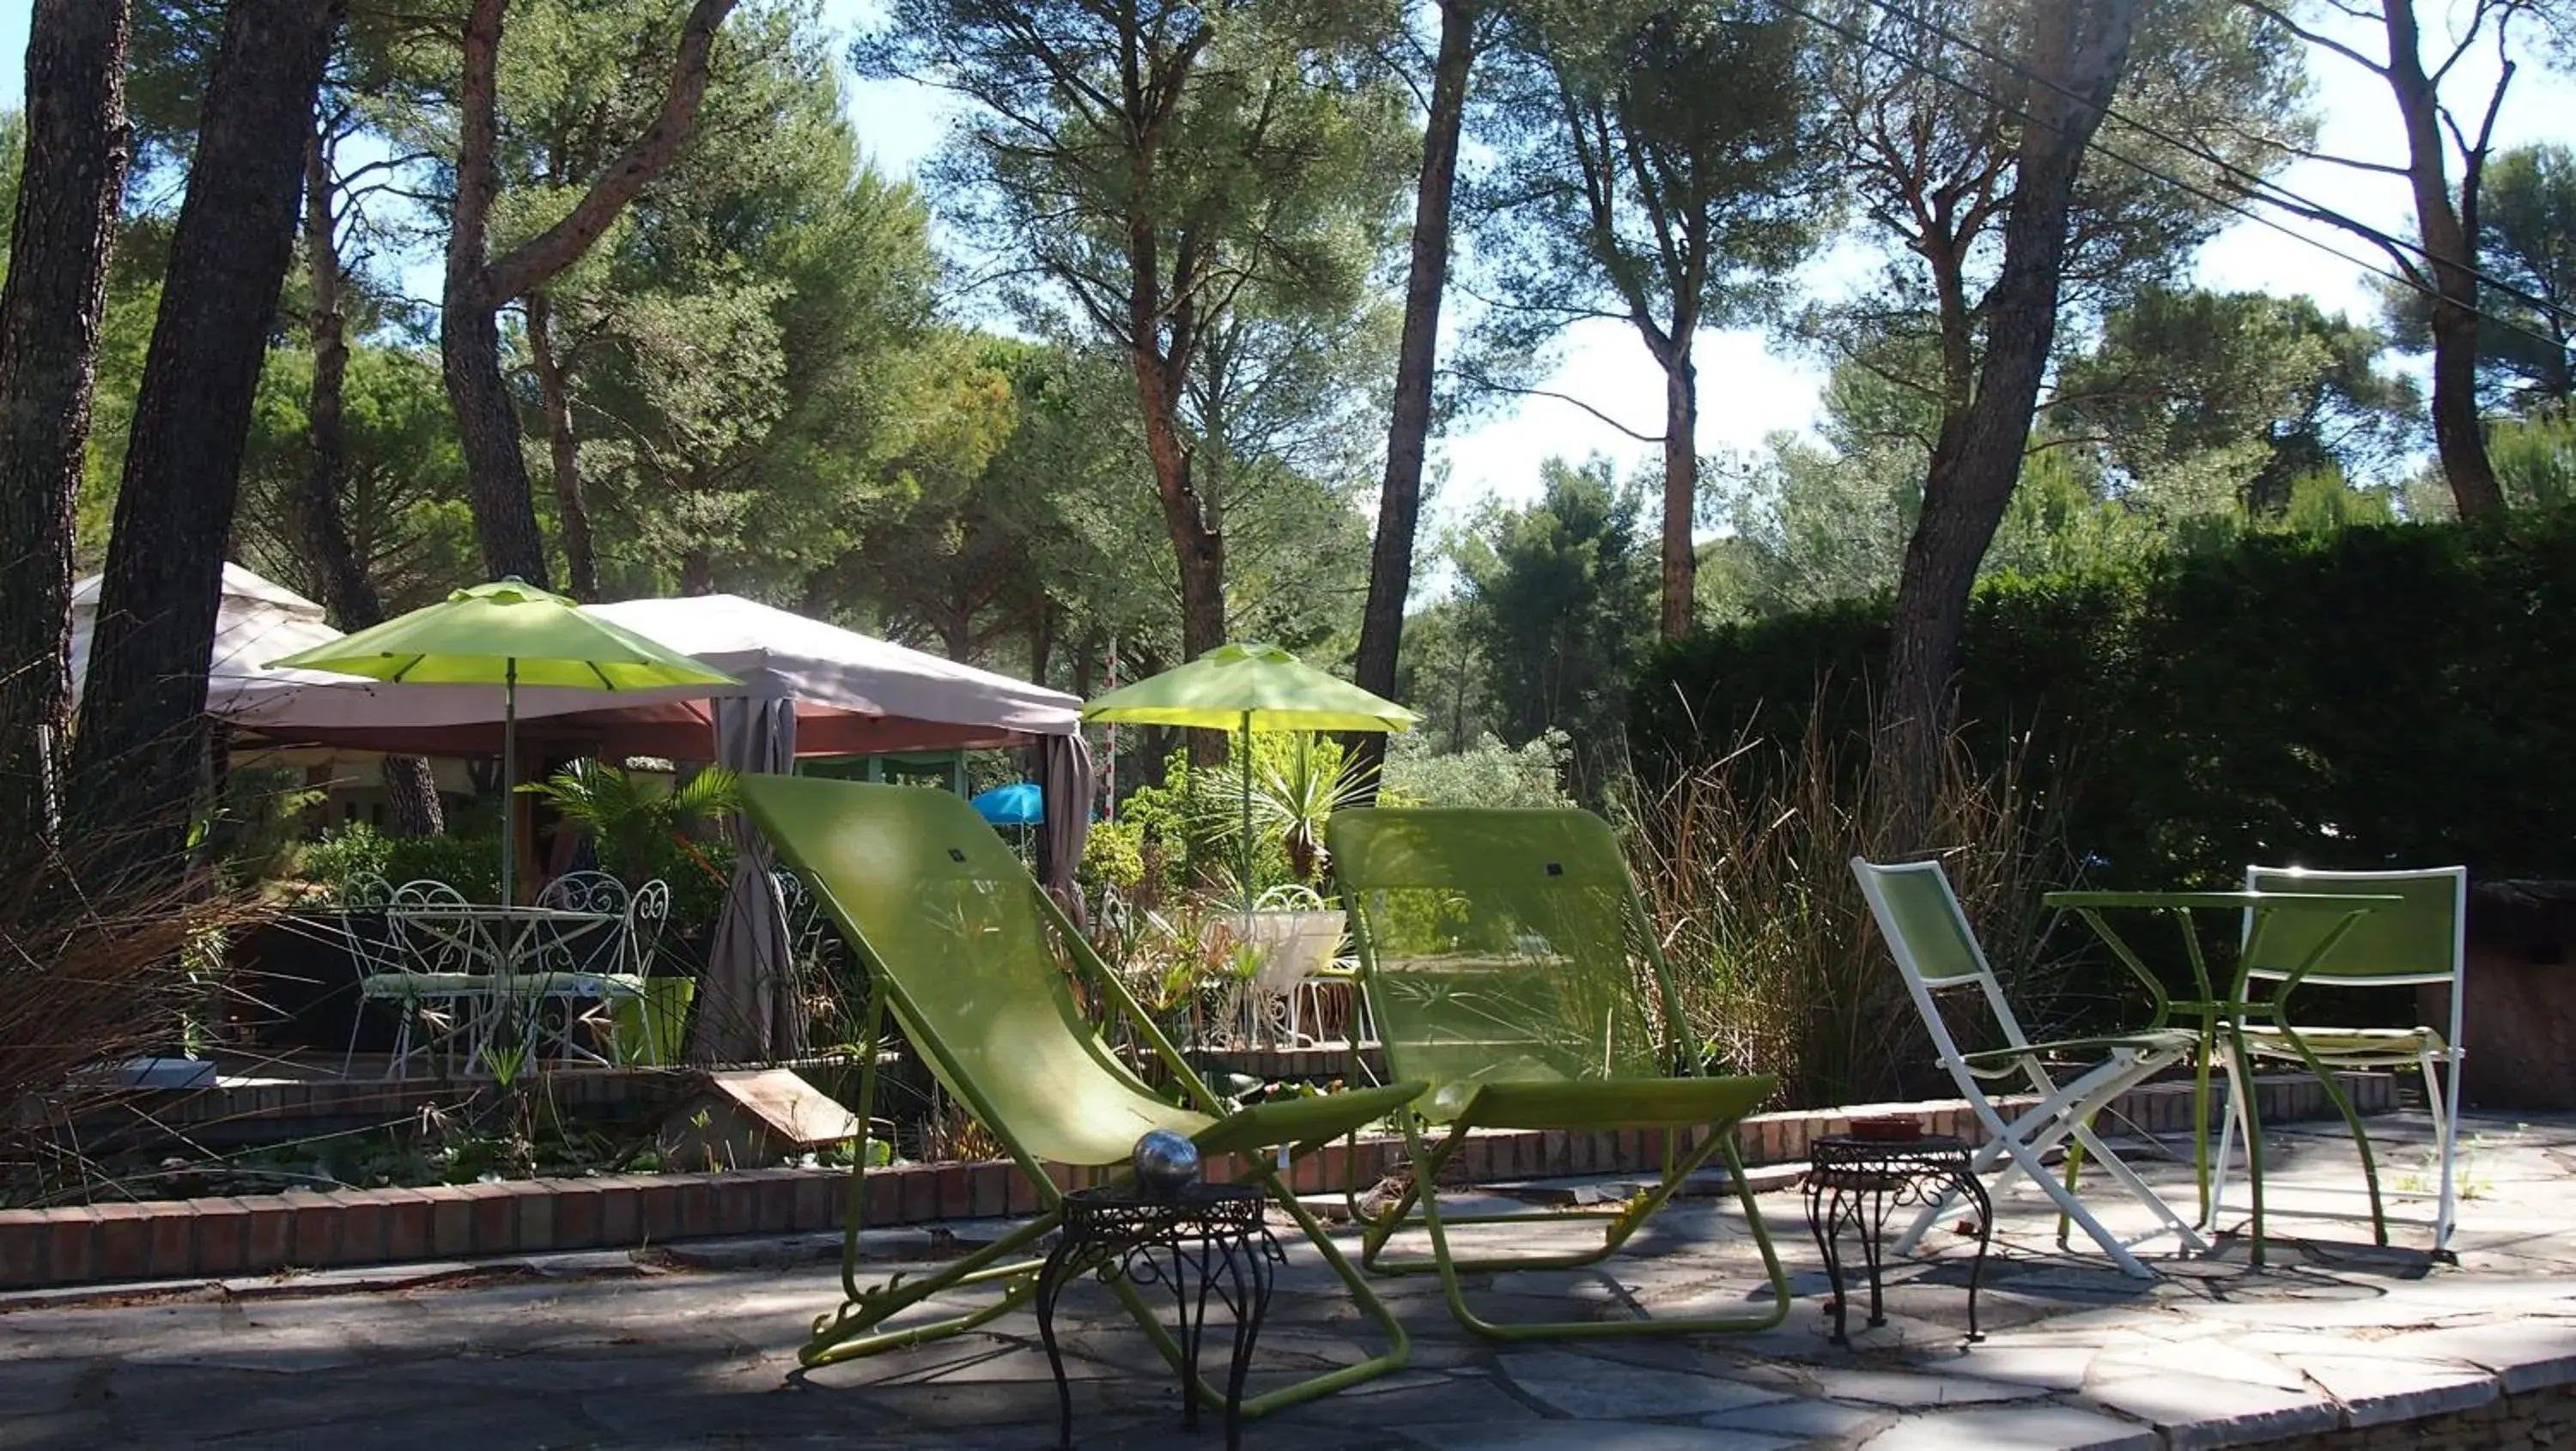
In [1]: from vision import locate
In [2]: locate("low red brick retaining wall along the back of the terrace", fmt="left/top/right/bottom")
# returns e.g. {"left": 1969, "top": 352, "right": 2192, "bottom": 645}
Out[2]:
{"left": 0, "top": 1075, "right": 2396, "bottom": 1291}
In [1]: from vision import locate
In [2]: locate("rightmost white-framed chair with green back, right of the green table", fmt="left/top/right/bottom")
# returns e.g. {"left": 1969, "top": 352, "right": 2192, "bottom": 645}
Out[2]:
{"left": 2208, "top": 866, "right": 2468, "bottom": 1255}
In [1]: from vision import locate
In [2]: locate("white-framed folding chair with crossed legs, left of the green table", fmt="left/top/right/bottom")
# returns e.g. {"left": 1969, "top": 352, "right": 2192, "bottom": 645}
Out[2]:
{"left": 1852, "top": 856, "right": 2208, "bottom": 1278}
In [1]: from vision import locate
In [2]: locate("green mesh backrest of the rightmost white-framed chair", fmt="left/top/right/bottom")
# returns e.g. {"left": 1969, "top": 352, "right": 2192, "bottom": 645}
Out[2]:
{"left": 2246, "top": 866, "right": 2468, "bottom": 987}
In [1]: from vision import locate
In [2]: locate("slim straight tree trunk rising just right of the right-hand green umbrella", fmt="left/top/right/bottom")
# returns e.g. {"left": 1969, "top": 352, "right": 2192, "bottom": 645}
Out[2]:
{"left": 1345, "top": 0, "right": 1479, "bottom": 802}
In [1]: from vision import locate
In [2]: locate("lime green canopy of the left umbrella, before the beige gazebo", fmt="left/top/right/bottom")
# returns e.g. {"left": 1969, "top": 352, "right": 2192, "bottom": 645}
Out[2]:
{"left": 270, "top": 580, "right": 739, "bottom": 690}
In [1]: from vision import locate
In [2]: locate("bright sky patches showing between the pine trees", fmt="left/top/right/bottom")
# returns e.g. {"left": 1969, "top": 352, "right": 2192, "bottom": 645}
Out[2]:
{"left": 0, "top": 0, "right": 2576, "bottom": 518}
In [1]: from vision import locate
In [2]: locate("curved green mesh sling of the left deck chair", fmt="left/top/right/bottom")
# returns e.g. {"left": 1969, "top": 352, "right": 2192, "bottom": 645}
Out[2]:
{"left": 742, "top": 776, "right": 1211, "bottom": 1165}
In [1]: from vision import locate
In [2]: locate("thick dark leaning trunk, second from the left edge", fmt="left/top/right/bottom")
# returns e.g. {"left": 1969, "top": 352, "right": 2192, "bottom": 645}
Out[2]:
{"left": 70, "top": 0, "right": 340, "bottom": 884}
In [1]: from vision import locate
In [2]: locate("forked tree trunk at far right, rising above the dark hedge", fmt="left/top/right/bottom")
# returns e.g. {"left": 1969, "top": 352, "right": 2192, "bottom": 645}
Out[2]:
{"left": 2380, "top": 0, "right": 2512, "bottom": 518}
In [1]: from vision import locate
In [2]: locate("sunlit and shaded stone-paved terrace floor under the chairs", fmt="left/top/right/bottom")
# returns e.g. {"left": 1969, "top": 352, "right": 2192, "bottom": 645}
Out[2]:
{"left": 0, "top": 1116, "right": 2576, "bottom": 1451}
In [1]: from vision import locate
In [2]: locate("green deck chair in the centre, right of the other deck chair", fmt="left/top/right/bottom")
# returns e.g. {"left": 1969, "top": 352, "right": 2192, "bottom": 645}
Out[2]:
{"left": 1327, "top": 810, "right": 1790, "bottom": 1340}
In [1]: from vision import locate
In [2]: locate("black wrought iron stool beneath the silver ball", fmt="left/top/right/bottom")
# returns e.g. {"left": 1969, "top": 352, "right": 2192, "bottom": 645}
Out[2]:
{"left": 1015, "top": 1183, "right": 1288, "bottom": 1451}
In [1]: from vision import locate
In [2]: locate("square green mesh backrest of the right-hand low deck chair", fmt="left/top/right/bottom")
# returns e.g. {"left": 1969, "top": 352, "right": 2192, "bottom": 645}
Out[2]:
{"left": 1329, "top": 810, "right": 1672, "bottom": 1121}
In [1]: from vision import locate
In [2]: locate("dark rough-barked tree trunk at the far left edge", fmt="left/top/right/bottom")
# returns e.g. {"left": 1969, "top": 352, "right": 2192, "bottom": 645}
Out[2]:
{"left": 0, "top": 0, "right": 134, "bottom": 851}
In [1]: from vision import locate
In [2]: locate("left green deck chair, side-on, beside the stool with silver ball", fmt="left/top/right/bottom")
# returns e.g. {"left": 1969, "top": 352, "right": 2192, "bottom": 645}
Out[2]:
{"left": 742, "top": 776, "right": 1422, "bottom": 1418}
